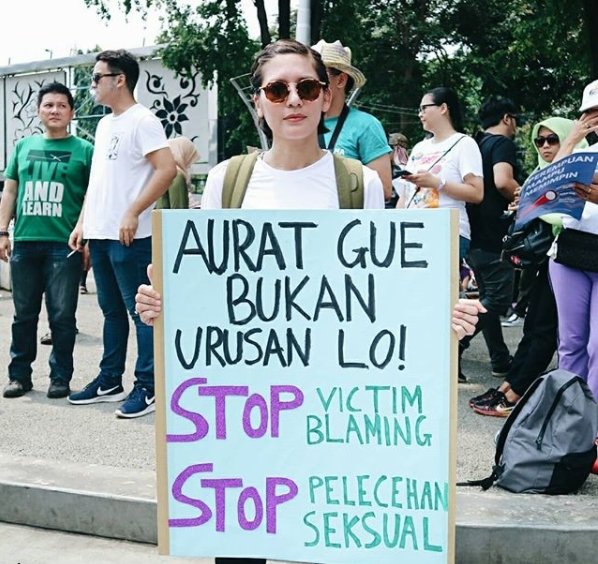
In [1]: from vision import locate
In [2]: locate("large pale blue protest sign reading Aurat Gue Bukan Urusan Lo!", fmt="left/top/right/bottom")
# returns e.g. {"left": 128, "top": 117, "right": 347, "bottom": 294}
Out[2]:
{"left": 153, "top": 210, "right": 458, "bottom": 564}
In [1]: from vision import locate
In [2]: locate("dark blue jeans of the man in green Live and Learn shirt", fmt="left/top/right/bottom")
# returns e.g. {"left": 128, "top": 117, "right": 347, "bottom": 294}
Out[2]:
{"left": 8, "top": 241, "right": 81, "bottom": 384}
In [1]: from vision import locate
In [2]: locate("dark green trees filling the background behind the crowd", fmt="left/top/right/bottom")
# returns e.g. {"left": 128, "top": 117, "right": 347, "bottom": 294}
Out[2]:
{"left": 84, "top": 0, "right": 598, "bottom": 156}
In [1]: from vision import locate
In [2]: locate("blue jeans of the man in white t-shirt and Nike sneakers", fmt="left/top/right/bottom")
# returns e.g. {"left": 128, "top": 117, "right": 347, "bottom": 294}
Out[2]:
{"left": 89, "top": 237, "right": 154, "bottom": 392}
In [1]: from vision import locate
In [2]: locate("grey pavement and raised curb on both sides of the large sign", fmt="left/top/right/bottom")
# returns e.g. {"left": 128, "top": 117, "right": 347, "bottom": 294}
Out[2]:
{"left": 0, "top": 276, "right": 598, "bottom": 564}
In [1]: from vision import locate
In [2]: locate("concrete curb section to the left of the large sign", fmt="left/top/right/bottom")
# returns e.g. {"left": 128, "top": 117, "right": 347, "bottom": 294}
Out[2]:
{"left": 0, "top": 455, "right": 157, "bottom": 544}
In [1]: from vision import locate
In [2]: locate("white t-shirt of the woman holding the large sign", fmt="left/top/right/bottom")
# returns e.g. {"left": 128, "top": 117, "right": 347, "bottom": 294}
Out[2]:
{"left": 201, "top": 151, "right": 384, "bottom": 210}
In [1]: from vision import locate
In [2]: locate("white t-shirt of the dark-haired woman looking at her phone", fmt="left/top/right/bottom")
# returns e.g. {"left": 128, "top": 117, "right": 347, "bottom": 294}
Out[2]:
{"left": 393, "top": 133, "right": 484, "bottom": 239}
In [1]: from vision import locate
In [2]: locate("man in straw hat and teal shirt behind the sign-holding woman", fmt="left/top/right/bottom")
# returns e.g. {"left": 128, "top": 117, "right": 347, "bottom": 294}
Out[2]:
{"left": 313, "top": 39, "right": 392, "bottom": 199}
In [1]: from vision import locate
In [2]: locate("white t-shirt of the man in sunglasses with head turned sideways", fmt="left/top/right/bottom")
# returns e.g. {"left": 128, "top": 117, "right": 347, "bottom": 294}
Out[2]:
{"left": 83, "top": 104, "right": 168, "bottom": 240}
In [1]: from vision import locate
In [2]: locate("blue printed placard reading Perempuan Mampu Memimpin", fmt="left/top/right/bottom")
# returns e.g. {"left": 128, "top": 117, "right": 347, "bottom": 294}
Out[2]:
{"left": 515, "top": 152, "right": 598, "bottom": 229}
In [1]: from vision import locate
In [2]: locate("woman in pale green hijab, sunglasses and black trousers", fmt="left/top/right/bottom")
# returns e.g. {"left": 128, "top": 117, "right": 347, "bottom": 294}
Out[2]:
{"left": 469, "top": 117, "right": 587, "bottom": 417}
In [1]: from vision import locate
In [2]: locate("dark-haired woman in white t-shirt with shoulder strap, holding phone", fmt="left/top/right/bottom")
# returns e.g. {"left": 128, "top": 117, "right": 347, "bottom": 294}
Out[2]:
{"left": 397, "top": 87, "right": 484, "bottom": 259}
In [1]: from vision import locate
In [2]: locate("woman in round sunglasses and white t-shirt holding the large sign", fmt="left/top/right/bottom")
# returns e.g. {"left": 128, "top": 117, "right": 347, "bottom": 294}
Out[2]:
{"left": 135, "top": 40, "right": 484, "bottom": 564}
